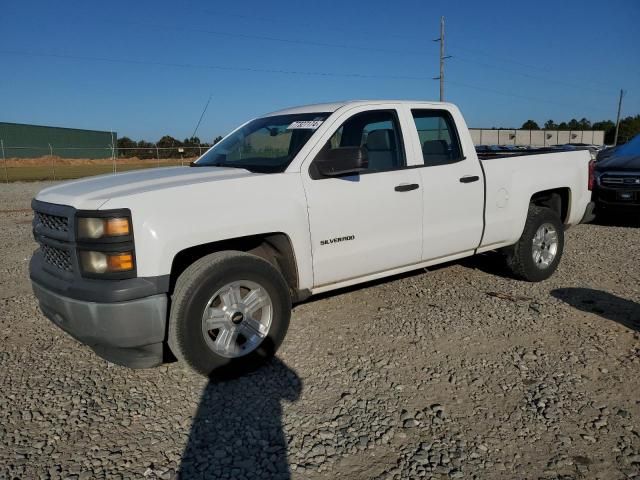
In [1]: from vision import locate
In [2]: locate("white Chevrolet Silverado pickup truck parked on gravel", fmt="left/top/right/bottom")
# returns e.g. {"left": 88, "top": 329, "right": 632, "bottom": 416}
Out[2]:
{"left": 30, "top": 101, "right": 593, "bottom": 377}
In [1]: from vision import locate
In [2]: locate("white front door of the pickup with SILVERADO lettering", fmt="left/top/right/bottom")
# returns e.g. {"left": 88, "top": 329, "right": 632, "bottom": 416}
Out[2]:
{"left": 302, "top": 107, "right": 422, "bottom": 288}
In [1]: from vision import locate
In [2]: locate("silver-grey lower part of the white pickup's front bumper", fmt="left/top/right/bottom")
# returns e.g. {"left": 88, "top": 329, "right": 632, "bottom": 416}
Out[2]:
{"left": 31, "top": 280, "right": 168, "bottom": 368}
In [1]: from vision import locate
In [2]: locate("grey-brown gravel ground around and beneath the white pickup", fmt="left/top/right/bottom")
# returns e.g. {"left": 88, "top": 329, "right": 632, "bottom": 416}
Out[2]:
{"left": 0, "top": 183, "right": 640, "bottom": 480}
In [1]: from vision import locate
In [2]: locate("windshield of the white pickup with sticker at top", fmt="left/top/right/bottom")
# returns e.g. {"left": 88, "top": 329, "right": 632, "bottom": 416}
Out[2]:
{"left": 193, "top": 113, "right": 330, "bottom": 173}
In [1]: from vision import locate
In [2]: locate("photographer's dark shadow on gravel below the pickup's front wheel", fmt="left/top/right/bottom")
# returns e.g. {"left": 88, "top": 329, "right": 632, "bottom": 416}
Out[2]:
{"left": 177, "top": 358, "right": 302, "bottom": 480}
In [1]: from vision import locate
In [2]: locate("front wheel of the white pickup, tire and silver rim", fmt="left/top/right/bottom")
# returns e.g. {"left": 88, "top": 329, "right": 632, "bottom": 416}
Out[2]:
{"left": 168, "top": 251, "right": 291, "bottom": 379}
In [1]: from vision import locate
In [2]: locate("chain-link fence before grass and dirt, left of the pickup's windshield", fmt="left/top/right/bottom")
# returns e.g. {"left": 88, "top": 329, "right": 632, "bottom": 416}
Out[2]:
{"left": 0, "top": 139, "right": 209, "bottom": 183}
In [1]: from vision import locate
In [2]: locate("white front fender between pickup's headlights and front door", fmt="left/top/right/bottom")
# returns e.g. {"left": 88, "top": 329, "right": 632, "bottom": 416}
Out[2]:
{"left": 102, "top": 173, "right": 313, "bottom": 288}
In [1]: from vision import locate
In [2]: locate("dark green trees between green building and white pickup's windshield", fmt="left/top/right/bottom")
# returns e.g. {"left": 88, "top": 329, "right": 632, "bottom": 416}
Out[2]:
{"left": 117, "top": 135, "right": 222, "bottom": 159}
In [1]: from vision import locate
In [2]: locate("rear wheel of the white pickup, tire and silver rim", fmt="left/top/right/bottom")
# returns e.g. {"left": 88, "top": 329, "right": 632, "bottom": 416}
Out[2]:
{"left": 505, "top": 205, "right": 564, "bottom": 282}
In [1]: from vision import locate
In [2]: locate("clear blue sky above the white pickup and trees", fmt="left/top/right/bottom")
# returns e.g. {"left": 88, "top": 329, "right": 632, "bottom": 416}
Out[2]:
{"left": 0, "top": 0, "right": 640, "bottom": 141}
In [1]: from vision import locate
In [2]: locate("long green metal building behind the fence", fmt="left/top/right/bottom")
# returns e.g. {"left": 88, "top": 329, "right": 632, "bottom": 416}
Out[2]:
{"left": 0, "top": 122, "right": 118, "bottom": 158}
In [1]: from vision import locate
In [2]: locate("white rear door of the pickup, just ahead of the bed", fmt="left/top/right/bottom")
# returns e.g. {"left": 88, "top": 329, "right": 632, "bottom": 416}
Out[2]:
{"left": 407, "top": 108, "right": 484, "bottom": 261}
